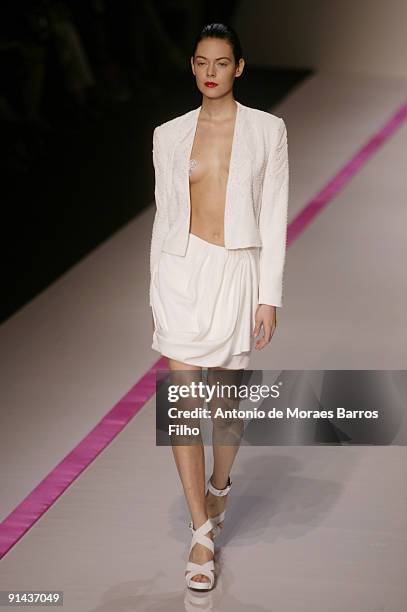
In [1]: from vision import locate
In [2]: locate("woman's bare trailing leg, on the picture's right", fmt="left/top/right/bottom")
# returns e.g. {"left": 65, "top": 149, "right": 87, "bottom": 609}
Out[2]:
{"left": 206, "top": 368, "right": 244, "bottom": 527}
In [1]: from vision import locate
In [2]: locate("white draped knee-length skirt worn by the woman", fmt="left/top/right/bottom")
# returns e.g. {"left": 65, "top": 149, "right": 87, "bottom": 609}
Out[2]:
{"left": 151, "top": 233, "right": 259, "bottom": 369}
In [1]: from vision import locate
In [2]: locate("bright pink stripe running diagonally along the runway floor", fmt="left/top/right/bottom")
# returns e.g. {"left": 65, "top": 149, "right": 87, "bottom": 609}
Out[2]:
{"left": 0, "top": 97, "right": 407, "bottom": 559}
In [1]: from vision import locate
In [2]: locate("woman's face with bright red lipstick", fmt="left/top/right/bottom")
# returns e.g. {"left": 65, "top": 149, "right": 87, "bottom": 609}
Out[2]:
{"left": 191, "top": 38, "right": 244, "bottom": 98}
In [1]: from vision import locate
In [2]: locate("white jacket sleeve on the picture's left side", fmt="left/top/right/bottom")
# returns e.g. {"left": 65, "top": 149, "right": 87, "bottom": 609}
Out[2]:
{"left": 149, "top": 126, "right": 169, "bottom": 306}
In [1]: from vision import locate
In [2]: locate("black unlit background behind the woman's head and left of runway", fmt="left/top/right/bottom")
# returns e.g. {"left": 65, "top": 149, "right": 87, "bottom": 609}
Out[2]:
{"left": 0, "top": 0, "right": 310, "bottom": 321}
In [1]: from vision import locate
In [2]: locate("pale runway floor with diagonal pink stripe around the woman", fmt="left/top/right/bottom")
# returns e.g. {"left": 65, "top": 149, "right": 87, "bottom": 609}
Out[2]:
{"left": 0, "top": 73, "right": 407, "bottom": 612}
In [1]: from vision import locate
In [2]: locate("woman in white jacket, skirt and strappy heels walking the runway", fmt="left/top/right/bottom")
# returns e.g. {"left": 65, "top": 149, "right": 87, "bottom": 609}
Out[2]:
{"left": 150, "top": 23, "right": 289, "bottom": 590}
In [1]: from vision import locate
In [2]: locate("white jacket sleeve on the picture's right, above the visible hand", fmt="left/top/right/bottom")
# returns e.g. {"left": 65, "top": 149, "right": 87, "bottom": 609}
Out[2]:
{"left": 258, "top": 118, "right": 289, "bottom": 307}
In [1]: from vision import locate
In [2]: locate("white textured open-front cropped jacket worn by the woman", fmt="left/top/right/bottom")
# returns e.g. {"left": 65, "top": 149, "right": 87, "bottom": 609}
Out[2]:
{"left": 150, "top": 100, "right": 289, "bottom": 306}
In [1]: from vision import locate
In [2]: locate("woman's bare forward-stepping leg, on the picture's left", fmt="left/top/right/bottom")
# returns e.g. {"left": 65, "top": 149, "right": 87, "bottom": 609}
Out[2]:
{"left": 168, "top": 359, "right": 213, "bottom": 582}
